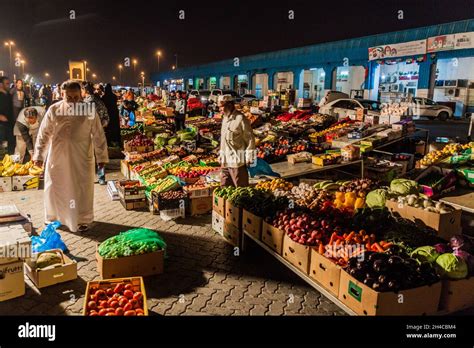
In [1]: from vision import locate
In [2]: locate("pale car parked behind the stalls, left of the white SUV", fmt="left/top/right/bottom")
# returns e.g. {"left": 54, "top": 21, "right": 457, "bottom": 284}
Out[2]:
{"left": 319, "top": 98, "right": 381, "bottom": 118}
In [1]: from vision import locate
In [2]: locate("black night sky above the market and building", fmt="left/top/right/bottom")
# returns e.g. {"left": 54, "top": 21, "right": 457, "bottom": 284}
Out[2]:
{"left": 0, "top": 0, "right": 474, "bottom": 82}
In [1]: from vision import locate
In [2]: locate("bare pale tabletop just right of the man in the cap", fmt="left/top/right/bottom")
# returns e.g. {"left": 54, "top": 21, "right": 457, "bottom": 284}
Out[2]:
{"left": 250, "top": 160, "right": 364, "bottom": 185}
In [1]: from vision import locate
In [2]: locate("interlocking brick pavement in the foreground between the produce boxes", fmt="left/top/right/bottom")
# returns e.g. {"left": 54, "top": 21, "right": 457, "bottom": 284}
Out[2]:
{"left": 0, "top": 162, "right": 344, "bottom": 315}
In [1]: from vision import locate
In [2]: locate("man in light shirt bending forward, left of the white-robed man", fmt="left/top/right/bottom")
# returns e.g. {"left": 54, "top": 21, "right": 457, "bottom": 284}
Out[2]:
{"left": 13, "top": 106, "right": 44, "bottom": 163}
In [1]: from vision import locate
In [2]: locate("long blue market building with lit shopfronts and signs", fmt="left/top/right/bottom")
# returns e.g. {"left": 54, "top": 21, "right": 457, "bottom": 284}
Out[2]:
{"left": 151, "top": 19, "right": 474, "bottom": 116}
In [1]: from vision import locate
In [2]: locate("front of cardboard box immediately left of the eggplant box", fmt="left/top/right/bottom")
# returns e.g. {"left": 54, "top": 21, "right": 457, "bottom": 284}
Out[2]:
{"left": 309, "top": 248, "right": 342, "bottom": 296}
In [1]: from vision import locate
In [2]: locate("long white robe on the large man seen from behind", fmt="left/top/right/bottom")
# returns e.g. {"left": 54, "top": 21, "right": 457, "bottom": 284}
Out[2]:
{"left": 33, "top": 101, "right": 109, "bottom": 232}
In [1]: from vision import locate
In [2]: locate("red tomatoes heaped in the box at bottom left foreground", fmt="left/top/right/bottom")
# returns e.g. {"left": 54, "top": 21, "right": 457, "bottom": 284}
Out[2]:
{"left": 86, "top": 283, "right": 145, "bottom": 317}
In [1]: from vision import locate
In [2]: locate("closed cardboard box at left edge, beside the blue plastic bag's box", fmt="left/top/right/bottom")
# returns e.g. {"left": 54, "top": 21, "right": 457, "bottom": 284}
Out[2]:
{"left": 0, "top": 261, "right": 25, "bottom": 302}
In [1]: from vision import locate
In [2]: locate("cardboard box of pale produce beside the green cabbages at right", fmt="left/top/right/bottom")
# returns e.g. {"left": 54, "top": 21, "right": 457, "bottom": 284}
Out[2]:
{"left": 385, "top": 200, "right": 461, "bottom": 240}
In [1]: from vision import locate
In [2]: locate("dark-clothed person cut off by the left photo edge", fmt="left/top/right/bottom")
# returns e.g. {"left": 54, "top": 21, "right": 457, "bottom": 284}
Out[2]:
{"left": 0, "top": 76, "right": 15, "bottom": 154}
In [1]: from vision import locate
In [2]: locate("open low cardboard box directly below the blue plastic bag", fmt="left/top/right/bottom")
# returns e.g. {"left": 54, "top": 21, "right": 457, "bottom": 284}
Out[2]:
{"left": 25, "top": 249, "right": 77, "bottom": 289}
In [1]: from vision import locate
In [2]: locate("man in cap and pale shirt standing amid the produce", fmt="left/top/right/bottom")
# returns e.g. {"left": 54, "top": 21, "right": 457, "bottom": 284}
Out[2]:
{"left": 218, "top": 95, "right": 256, "bottom": 186}
